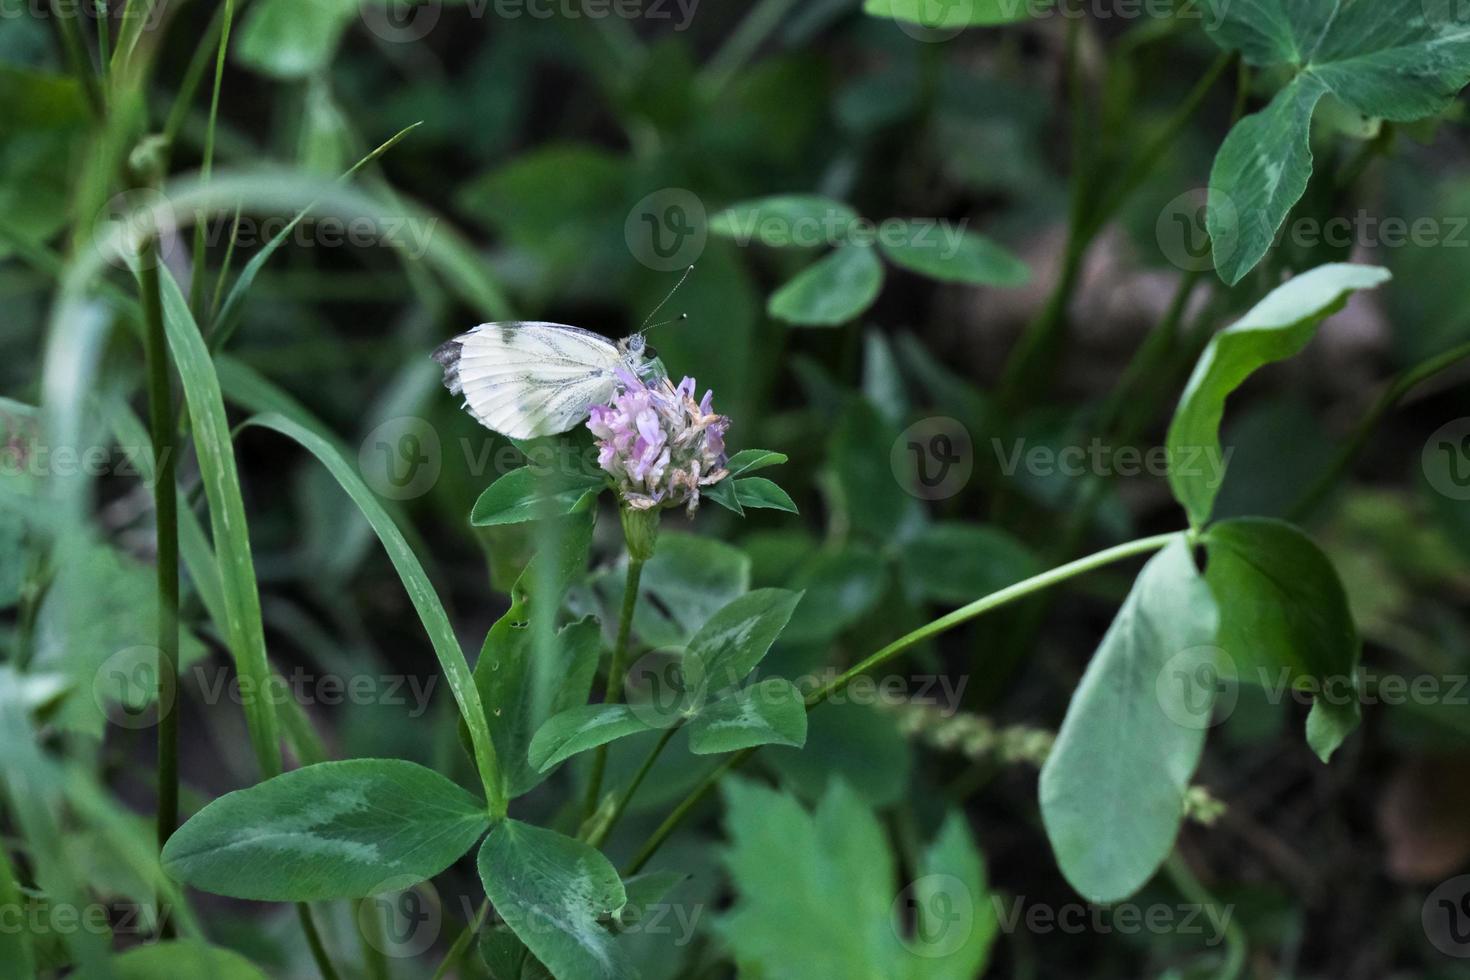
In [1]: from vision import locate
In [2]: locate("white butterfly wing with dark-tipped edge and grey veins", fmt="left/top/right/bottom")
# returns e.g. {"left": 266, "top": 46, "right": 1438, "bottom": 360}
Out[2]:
{"left": 434, "top": 320, "right": 623, "bottom": 439}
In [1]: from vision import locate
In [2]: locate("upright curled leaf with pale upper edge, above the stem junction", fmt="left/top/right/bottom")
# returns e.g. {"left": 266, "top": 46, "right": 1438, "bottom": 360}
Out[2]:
{"left": 1167, "top": 264, "right": 1392, "bottom": 527}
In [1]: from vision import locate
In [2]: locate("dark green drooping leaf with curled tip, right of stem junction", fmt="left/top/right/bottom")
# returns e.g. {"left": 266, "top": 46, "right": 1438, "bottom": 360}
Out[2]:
{"left": 1204, "top": 517, "right": 1361, "bottom": 763}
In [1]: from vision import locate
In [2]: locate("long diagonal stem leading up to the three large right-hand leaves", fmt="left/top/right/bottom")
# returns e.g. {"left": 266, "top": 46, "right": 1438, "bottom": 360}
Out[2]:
{"left": 623, "top": 530, "right": 1189, "bottom": 876}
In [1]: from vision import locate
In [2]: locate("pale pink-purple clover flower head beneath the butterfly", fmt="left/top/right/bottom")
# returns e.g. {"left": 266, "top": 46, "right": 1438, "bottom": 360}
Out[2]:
{"left": 587, "top": 370, "right": 729, "bottom": 514}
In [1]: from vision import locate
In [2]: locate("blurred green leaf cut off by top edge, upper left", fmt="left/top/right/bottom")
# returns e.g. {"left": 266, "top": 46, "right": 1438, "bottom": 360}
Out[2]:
{"left": 235, "top": 0, "right": 360, "bottom": 78}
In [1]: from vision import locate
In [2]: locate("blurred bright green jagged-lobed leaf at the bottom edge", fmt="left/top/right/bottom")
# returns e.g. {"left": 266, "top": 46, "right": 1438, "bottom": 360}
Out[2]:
{"left": 716, "top": 779, "right": 997, "bottom": 980}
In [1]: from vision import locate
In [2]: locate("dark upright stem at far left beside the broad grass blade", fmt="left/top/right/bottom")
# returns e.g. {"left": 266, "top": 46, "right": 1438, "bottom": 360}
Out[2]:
{"left": 138, "top": 238, "right": 179, "bottom": 851}
